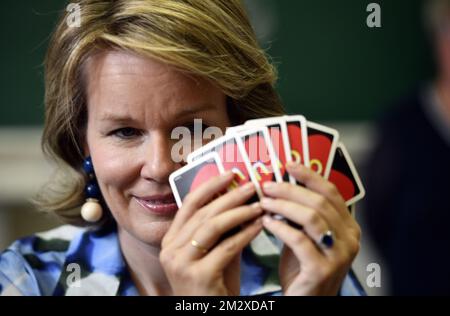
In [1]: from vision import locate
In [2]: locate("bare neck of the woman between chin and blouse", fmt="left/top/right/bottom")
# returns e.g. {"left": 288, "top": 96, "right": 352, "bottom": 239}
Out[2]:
{"left": 118, "top": 228, "right": 172, "bottom": 296}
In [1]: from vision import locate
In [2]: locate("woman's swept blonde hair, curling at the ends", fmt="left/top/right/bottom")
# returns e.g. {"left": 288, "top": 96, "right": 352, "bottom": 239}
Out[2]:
{"left": 36, "top": 0, "right": 284, "bottom": 225}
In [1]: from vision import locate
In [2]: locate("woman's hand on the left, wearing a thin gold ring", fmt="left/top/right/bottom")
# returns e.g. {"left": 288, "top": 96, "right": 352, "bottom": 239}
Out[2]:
{"left": 160, "top": 172, "right": 263, "bottom": 296}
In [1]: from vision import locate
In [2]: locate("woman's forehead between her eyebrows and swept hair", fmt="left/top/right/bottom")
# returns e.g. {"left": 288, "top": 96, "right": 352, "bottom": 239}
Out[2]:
{"left": 84, "top": 51, "right": 225, "bottom": 123}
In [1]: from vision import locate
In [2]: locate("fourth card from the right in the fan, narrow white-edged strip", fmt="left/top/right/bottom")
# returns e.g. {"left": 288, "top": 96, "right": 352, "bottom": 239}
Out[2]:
{"left": 245, "top": 117, "right": 295, "bottom": 182}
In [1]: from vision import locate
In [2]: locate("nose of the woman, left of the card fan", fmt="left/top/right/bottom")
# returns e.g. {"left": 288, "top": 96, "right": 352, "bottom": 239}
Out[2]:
{"left": 141, "top": 132, "right": 183, "bottom": 183}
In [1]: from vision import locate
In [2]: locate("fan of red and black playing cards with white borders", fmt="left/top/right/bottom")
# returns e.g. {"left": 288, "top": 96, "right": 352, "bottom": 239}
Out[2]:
{"left": 169, "top": 115, "right": 365, "bottom": 207}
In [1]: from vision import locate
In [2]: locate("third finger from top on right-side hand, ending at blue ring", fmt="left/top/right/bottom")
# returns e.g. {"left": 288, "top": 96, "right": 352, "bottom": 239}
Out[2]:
{"left": 261, "top": 198, "right": 330, "bottom": 243}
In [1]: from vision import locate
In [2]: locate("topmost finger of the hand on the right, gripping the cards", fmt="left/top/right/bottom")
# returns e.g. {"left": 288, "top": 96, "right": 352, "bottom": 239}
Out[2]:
{"left": 286, "top": 162, "right": 351, "bottom": 220}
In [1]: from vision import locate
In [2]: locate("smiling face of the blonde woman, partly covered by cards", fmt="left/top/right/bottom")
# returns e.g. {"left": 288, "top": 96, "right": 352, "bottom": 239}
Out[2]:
{"left": 85, "top": 51, "right": 230, "bottom": 247}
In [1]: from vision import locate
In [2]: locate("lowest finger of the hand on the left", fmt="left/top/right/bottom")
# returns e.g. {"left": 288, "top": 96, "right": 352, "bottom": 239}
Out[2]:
{"left": 202, "top": 218, "right": 263, "bottom": 270}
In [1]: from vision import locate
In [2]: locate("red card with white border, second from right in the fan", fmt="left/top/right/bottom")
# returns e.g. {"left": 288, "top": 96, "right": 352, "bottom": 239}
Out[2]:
{"left": 306, "top": 122, "right": 339, "bottom": 179}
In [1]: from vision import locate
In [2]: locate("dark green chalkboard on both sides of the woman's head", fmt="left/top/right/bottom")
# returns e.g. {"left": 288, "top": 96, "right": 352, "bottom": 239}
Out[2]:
{"left": 0, "top": 0, "right": 433, "bottom": 126}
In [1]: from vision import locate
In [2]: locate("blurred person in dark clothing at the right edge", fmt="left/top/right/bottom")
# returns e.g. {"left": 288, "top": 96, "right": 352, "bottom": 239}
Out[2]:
{"left": 366, "top": 0, "right": 450, "bottom": 295}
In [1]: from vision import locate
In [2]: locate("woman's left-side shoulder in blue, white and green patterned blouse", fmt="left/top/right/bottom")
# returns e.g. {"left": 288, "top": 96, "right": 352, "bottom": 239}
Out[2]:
{"left": 0, "top": 225, "right": 85, "bottom": 295}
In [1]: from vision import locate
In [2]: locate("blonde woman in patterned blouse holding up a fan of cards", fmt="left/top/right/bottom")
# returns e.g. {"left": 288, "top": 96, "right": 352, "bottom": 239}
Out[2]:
{"left": 0, "top": 0, "right": 360, "bottom": 295}
